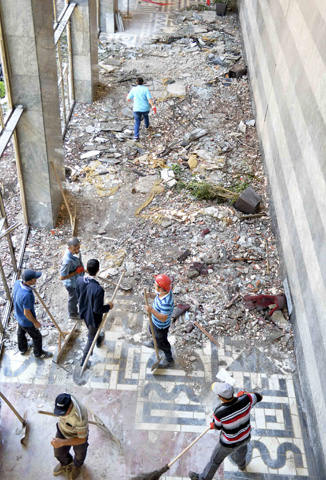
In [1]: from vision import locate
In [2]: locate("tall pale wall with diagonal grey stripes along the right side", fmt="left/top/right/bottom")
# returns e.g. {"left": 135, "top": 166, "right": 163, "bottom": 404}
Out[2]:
{"left": 238, "top": 0, "right": 326, "bottom": 472}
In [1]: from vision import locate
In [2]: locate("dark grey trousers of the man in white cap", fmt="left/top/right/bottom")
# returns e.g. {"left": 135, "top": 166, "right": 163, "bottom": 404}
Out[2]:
{"left": 199, "top": 439, "right": 250, "bottom": 480}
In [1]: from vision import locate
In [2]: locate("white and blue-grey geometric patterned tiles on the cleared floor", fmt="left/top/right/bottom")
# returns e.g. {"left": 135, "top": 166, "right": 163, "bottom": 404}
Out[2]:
{"left": 0, "top": 297, "right": 318, "bottom": 480}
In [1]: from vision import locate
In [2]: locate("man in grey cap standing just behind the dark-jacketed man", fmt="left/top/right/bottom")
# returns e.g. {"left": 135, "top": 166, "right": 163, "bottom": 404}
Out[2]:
{"left": 60, "top": 237, "right": 84, "bottom": 318}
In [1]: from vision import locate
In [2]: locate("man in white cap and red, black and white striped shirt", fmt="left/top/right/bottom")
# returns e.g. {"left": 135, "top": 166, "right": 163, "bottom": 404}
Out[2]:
{"left": 189, "top": 383, "right": 263, "bottom": 480}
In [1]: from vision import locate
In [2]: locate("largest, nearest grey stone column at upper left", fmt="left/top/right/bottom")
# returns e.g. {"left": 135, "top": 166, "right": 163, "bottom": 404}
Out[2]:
{"left": 1, "top": 0, "right": 64, "bottom": 228}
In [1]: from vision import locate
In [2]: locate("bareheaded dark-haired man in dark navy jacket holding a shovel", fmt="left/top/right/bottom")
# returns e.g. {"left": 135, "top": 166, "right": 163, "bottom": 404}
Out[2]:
{"left": 76, "top": 258, "right": 113, "bottom": 366}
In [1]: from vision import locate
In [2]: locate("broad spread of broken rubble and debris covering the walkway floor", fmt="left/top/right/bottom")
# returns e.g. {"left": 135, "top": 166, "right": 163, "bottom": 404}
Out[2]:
{"left": 0, "top": 11, "right": 294, "bottom": 371}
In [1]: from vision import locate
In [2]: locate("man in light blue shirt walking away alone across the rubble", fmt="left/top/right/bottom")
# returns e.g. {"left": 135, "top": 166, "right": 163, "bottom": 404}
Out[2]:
{"left": 127, "top": 77, "right": 156, "bottom": 140}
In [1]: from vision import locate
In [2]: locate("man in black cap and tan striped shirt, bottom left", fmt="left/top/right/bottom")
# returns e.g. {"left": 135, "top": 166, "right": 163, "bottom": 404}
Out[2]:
{"left": 51, "top": 393, "right": 88, "bottom": 480}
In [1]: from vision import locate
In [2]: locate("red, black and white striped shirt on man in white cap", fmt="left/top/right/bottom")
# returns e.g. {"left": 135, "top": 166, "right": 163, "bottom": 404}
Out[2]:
{"left": 214, "top": 393, "right": 263, "bottom": 447}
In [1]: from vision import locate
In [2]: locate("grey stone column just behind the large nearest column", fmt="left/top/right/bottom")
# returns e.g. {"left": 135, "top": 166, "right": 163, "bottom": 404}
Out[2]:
{"left": 71, "top": 0, "right": 98, "bottom": 103}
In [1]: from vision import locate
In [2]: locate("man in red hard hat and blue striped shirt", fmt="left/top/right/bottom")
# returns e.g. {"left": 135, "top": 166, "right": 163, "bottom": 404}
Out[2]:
{"left": 144, "top": 274, "right": 174, "bottom": 368}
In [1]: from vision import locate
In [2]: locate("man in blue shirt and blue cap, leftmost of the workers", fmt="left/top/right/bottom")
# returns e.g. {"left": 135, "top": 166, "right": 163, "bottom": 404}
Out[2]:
{"left": 13, "top": 270, "right": 53, "bottom": 358}
